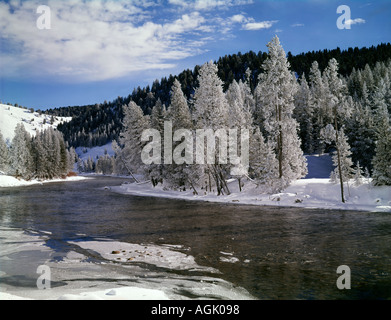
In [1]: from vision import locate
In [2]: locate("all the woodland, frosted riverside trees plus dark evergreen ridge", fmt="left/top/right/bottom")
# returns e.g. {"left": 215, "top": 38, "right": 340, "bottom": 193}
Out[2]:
{"left": 0, "top": 36, "right": 391, "bottom": 194}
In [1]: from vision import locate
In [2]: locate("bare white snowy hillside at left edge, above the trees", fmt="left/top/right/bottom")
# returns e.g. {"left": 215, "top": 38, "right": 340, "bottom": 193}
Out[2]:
{"left": 0, "top": 104, "right": 72, "bottom": 145}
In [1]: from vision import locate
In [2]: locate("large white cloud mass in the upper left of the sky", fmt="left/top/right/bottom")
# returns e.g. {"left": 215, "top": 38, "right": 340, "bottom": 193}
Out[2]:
{"left": 0, "top": 0, "right": 210, "bottom": 82}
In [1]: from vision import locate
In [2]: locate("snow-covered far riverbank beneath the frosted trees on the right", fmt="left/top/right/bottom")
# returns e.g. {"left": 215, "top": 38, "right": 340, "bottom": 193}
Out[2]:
{"left": 112, "top": 179, "right": 391, "bottom": 212}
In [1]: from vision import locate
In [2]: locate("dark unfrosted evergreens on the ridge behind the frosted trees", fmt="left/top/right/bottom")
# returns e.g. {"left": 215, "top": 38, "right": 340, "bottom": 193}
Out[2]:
{"left": 46, "top": 43, "right": 391, "bottom": 148}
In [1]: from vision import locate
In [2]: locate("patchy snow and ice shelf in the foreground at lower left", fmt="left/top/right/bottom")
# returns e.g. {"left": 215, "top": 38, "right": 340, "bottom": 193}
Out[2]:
{"left": 0, "top": 227, "right": 254, "bottom": 300}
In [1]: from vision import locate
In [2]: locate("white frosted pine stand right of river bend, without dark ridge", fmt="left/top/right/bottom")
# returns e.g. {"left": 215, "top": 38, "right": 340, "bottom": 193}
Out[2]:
{"left": 79, "top": 37, "right": 391, "bottom": 196}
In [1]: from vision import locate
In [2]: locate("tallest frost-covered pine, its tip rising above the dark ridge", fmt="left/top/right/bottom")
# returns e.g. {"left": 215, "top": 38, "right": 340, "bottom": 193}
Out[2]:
{"left": 257, "top": 36, "right": 307, "bottom": 186}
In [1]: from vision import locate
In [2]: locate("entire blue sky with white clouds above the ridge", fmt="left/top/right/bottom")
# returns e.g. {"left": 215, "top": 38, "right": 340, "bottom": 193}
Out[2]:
{"left": 0, "top": 0, "right": 391, "bottom": 110}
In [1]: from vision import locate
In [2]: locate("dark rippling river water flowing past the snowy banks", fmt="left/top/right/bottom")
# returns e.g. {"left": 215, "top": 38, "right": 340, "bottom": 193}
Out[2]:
{"left": 0, "top": 177, "right": 391, "bottom": 299}
